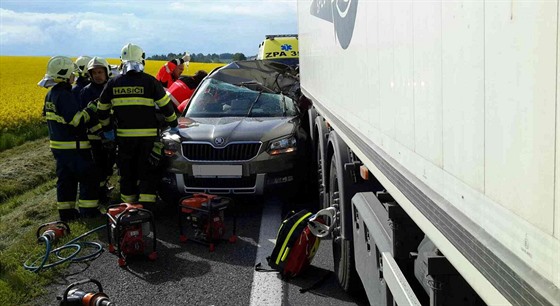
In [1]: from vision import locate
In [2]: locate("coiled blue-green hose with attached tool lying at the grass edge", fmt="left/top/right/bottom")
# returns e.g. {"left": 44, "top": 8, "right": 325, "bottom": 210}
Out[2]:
{"left": 23, "top": 221, "right": 106, "bottom": 273}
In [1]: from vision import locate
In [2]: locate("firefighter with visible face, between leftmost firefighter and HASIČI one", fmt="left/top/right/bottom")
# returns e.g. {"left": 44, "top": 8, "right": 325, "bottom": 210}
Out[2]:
{"left": 80, "top": 57, "right": 115, "bottom": 203}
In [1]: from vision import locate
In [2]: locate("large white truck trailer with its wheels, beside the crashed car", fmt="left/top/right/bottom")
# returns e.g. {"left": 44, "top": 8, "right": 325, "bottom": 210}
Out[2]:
{"left": 298, "top": 0, "right": 560, "bottom": 306}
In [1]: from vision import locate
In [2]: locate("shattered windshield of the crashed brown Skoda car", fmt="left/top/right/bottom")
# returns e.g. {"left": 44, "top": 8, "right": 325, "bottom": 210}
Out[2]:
{"left": 185, "top": 78, "right": 298, "bottom": 117}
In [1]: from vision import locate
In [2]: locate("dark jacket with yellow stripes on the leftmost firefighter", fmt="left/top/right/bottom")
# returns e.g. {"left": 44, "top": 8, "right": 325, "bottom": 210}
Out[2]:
{"left": 44, "top": 83, "right": 93, "bottom": 149}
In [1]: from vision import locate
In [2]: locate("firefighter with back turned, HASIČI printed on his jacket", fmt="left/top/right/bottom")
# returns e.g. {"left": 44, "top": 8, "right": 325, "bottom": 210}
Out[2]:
{"left": 98, "top": 43, "right": 178, "bottom": 211}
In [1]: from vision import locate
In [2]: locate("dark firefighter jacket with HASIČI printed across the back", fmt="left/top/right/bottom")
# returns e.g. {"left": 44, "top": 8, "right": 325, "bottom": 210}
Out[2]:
{"left": 97, "top": 71, "right": 177, "bottom": 137}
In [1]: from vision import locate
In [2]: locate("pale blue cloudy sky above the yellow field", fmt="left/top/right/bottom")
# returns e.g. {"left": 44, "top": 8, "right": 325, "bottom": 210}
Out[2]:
{"left": 0, "top": 0, "right": 297, "bottom": 57}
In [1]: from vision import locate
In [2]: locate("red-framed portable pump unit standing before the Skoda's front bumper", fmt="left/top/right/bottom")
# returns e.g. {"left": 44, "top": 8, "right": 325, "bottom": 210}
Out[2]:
{"left": 179, "top": 193, "right": 237, "bottom": 252}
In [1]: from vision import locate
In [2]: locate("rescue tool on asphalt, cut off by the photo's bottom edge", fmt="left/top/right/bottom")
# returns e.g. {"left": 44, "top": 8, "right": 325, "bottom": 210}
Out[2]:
{"left": 56, "top": 279, "right": 116, "bottom": 306}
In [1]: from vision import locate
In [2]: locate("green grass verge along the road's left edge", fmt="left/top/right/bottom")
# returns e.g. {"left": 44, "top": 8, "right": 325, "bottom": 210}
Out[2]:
{"left": 0, "top": 138, "right": 118, "bottom": 305}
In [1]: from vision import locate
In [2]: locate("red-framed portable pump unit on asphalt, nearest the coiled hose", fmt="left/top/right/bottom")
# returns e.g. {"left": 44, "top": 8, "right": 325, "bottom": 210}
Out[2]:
{"left": 107, "top": 203, "right": 157, "bottom": 267}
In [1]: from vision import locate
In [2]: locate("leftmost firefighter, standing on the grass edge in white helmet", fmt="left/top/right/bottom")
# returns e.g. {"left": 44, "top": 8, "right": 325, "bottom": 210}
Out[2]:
{"left": 38, "top": 56, "right": 99, "bottom": 221}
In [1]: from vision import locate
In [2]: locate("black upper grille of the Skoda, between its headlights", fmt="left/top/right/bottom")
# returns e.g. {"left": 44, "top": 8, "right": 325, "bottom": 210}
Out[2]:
{"left": 183, "top": 142, "right": 261, "bottom": 161}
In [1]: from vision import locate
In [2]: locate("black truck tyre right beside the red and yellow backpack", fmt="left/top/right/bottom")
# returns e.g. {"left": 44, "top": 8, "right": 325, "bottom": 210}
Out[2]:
{"left": 329, "top": 155, "right": 362, "bottom": 293}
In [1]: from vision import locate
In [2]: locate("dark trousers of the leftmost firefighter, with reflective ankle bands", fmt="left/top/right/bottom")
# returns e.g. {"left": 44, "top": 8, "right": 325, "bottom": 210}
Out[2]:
{"left": 51, "top": 149, "right": 98, "bottom": 210}
